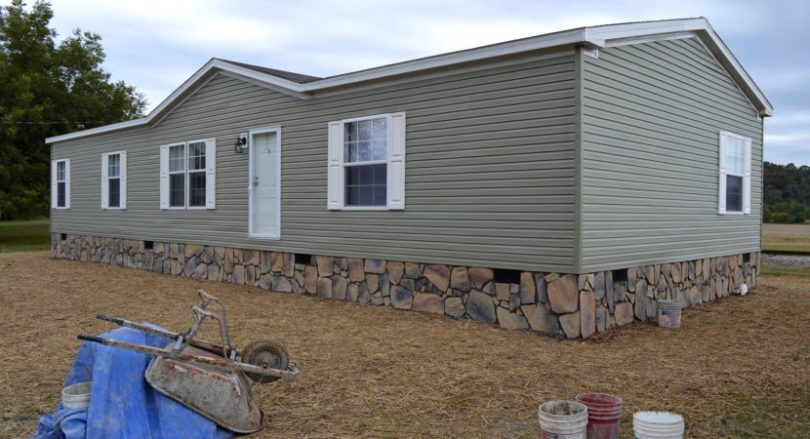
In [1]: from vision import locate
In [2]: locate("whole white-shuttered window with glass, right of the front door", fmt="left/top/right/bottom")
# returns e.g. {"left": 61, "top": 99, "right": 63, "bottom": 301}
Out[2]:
{"left": 327, "top": 113, "right": 405, "bottom": 210}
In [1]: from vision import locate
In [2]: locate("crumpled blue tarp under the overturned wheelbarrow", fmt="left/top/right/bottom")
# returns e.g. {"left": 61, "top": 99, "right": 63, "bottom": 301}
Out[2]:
{"left": 33, "top": 328, "right": 232, "bottom": 439}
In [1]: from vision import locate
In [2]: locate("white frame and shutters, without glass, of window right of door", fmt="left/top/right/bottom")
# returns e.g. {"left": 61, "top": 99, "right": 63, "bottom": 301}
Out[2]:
{"left": 327, "top": 112, "right": 406, "bottom": 212}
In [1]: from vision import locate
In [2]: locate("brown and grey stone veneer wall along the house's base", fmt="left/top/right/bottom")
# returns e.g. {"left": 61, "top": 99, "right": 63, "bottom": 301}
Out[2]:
{"left": 51, "top": 233, "right": 760, "bottom": 338}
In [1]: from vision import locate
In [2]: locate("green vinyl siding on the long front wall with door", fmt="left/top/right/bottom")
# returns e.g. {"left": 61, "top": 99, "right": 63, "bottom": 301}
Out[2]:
{"left": 51, "top": 54, "right": 576, "bottom": 272}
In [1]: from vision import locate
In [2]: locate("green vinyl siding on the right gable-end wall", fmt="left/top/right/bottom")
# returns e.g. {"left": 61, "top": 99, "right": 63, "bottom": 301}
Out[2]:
{"left": 579, "top": 39, "right": 762, "bottom": 272}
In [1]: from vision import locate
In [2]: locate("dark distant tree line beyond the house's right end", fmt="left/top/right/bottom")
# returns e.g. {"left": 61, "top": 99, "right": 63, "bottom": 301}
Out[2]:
{"left": 762, "top": 162, "right": 810, "bottom": 224}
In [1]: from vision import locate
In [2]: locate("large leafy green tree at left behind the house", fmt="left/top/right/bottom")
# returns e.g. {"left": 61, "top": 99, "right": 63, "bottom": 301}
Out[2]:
{"left": 0, "top": 0, "right": 146, "bottom": 219}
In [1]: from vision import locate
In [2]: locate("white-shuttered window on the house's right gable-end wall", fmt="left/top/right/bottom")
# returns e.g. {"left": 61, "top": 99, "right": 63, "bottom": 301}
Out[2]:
{"left": 718, "top": 132, "right": 751, "bottom": 214}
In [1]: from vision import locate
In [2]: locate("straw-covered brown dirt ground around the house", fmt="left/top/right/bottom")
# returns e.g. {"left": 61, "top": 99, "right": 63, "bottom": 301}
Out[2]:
{"left": 0, "top": 252, "right": 810, "bottom": 438}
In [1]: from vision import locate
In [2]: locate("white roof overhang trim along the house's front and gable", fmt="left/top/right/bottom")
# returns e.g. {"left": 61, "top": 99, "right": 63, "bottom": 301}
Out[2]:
{"left": 45, "top": 17, "right": 773, "bottom": 143}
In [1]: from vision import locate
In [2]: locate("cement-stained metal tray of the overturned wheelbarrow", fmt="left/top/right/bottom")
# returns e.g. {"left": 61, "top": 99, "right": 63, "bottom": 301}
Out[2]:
{"left": 145, "top": 345, "right": 267, "bottom": 433}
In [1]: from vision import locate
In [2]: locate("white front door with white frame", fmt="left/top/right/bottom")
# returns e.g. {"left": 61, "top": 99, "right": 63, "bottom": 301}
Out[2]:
{"left": 248, "top": 128, "right": 281, "bottom": 239}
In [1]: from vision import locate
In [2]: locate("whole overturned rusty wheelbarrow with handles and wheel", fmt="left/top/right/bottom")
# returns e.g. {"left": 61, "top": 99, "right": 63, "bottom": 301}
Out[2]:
{"left": 78, "top": 290, "right": 299, "bottom": 433}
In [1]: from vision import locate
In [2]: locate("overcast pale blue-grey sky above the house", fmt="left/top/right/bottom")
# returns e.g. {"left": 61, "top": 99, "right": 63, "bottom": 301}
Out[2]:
{"left": 7, "top": 0, "right": 810, "bottom": 165}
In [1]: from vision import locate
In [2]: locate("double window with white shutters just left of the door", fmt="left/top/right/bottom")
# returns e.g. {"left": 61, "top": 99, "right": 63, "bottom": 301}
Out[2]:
{"left": 160, "top": 139, "right": 216, "bottom": 209}
